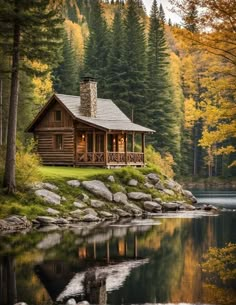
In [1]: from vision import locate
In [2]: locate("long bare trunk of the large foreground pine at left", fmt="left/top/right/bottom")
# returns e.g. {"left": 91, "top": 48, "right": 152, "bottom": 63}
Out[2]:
{"left": 3, "top": 18, "right": 20, "bottom": 193}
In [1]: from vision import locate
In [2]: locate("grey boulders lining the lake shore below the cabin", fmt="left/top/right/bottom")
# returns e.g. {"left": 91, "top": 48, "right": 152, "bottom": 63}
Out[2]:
{"left": 0, "top": 173, "right": 217, "bottom": 234}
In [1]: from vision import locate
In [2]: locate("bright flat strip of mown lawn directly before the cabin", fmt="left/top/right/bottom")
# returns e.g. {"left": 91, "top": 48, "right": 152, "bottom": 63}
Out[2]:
{"left": 40, "top": 166, "right": 114, "bottom": 180}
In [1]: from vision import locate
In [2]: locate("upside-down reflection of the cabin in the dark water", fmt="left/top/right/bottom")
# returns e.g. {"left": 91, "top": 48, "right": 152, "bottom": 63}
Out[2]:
{"left": 35, "top": 234, "right": 148, "bottom": 305}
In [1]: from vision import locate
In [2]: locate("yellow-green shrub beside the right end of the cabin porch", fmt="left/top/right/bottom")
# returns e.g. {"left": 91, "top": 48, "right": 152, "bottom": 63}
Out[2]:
{"left": 145, "top": 145, "right": 175, "bottom": 178}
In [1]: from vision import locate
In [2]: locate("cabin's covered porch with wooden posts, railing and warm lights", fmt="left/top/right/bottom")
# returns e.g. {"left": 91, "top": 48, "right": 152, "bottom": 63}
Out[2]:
{"left": 75, "top": 130, "right": 145, "bottom": 167}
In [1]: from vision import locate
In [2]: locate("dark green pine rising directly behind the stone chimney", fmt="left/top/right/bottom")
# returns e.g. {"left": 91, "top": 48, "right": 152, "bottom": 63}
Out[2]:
{"left": 84, "top": 0, "right": 109, "bottom": 97}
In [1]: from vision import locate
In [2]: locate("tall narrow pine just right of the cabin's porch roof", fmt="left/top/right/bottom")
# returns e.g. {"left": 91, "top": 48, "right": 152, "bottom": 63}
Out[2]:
{"left": 148, "top": 0, "right": 177, "bottom": 158}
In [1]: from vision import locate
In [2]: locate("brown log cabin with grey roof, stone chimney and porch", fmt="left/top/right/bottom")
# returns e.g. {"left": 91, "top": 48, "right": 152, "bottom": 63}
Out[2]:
{"left": 26, "top": 77, "right": 154, "bottom": 168}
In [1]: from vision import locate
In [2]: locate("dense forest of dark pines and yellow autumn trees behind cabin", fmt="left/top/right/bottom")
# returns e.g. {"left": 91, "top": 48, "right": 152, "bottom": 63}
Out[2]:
{"left": 0, "top": 0, "right": 236, "bottom": 188}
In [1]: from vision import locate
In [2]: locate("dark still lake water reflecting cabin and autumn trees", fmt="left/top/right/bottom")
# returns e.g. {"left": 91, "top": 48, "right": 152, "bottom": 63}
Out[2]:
{"left": 0, "top": 191, "right": 236, "bottom": 305}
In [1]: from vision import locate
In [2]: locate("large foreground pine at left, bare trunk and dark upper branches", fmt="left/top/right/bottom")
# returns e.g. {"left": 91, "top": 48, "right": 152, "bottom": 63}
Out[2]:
{"left": 0, "top": 0, "right": 62, "bottom": 193}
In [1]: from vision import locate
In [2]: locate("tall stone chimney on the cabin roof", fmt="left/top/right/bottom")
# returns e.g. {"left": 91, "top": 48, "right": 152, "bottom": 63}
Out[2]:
{"left": 80, "top": 76, "right": 97, "bottom": 118}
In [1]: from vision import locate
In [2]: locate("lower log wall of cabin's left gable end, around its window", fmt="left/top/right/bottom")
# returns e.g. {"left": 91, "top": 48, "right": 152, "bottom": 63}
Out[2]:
{"left": 36, "top": 131, "right": 74, "bottom": 165}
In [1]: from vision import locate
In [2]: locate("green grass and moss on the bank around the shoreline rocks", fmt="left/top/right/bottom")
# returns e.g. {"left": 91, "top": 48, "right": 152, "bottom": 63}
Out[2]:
{"left": 0, "top": 166, "right": 186, "bottom": 219}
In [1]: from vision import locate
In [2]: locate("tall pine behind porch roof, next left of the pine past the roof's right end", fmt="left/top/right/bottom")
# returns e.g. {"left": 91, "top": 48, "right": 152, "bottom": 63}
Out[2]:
{"left": 124, "top": 0, "right": 148, "bottom": 124}
